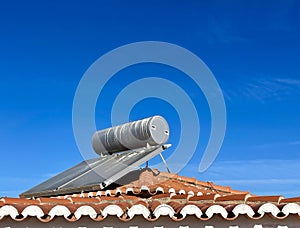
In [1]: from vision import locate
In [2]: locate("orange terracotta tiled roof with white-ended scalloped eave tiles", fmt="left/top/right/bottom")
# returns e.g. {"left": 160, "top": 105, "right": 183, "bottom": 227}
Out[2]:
{"left": 0, "top": 169, "right": 300, "bottom": 222}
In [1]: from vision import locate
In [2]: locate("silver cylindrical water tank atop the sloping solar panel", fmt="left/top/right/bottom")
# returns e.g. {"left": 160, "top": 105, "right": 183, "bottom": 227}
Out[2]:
{"left": 92, "top": 116, "right": 169, "bottom": 155}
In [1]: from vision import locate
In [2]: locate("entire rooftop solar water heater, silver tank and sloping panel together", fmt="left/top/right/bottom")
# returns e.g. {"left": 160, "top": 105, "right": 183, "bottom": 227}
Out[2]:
{"left": 20, "top": 116, "right": 169, "bottom": 197}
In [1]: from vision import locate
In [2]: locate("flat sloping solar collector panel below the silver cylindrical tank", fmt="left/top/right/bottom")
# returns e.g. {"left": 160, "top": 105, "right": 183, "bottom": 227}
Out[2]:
{"left": 20, "top": 146, "right": 166, "bottom": 198}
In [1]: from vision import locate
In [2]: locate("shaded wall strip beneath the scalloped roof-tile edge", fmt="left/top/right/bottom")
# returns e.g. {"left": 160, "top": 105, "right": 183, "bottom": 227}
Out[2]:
{"left": 0, "top": 215, "right": 300, "bottom": 228}
